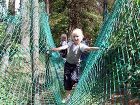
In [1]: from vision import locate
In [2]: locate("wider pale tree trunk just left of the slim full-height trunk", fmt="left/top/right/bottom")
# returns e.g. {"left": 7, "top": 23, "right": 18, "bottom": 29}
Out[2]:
{"left": 20, "top": 0, "right": 31, "bottom": 63}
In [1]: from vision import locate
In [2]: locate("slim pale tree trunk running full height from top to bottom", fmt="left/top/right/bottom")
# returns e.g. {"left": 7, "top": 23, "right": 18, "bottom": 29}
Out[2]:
{"left": 32, "top": 0, "right": 40, "bottom": 105}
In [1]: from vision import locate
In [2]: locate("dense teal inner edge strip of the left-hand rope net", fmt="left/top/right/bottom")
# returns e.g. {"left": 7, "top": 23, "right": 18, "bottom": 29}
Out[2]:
{"left": 40, "top": 2, "right": 64, "bottom": 104}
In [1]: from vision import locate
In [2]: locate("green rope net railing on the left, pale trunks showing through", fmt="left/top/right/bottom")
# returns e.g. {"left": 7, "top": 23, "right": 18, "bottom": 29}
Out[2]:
{"left": 0, "top": 1, "right": 63, "bottom": 105}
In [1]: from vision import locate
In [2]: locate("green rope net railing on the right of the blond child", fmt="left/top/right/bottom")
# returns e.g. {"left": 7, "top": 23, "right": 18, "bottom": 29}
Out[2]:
{"left": 69, "top": 0, "right": 140, "bottom": 105}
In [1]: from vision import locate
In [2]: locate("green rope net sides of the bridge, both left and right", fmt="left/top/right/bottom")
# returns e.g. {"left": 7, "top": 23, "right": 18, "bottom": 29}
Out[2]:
{"left": 0, "top": 0, "right": 140, "bottom": 105}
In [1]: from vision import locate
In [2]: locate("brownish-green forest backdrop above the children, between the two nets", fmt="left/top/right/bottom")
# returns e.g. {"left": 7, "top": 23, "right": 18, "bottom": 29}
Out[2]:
{"left": 46, "top": 0, "right": 115, "bottom": 46}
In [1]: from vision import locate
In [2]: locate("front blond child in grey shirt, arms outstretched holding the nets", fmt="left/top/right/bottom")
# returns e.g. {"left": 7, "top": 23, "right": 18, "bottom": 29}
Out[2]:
{"left": 52, "top": 28, "right": 100, "bottom": 103}
